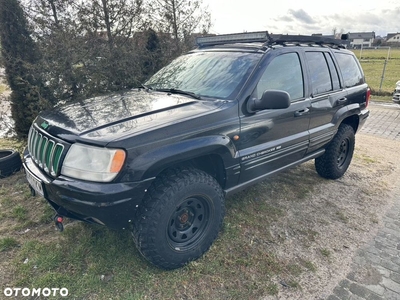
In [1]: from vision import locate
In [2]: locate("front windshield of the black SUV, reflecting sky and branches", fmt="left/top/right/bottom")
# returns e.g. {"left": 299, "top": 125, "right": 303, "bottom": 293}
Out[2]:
{"left": 145, "top": 52, "right": 261, "bottom": 99}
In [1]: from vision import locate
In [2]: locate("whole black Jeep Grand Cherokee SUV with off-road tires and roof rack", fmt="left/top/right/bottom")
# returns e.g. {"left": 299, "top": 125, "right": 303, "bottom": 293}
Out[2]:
{"left": 24, "top": 32, "right": 370, "bottom": 269}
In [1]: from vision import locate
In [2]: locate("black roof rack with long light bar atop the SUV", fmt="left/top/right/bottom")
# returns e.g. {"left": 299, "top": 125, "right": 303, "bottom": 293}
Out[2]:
{"left": 196, "top": 31, "right": 346, "bottom": 48}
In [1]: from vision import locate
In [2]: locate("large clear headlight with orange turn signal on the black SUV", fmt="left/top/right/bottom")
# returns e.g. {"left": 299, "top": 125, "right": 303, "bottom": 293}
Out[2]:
{"left": 61, "top": 144, "right": 126, "bottom": 182}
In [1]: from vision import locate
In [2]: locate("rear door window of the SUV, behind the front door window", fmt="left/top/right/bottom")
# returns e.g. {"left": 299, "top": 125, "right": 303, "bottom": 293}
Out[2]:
{"left": 306, "top": 52, "right": 333, "bottom": 96}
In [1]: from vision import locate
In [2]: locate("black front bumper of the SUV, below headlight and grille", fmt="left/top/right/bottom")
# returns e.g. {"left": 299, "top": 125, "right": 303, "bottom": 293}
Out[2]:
{"left": 23, "top": 153, "right": 154, "bottom": 229}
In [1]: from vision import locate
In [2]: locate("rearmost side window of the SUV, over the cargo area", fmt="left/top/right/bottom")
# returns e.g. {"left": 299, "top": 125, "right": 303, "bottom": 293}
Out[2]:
{"left": 335, "top": 53, "right": 363, "bottom": 87}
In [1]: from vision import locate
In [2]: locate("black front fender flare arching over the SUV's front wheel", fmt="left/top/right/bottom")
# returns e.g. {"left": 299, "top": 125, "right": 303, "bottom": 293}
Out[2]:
{"left": 129, "top": 135, "right": 239, "bottom": 180}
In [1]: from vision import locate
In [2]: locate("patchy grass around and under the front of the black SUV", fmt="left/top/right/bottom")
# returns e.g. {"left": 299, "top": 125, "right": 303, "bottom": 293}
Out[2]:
{"left": 0, "top": 139, "right": 318, "bottom": 300}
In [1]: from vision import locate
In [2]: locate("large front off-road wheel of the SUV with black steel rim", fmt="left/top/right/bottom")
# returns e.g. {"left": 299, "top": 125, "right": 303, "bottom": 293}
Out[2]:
{"left": 132, "top": 168, "right": 225, "bottom": 269}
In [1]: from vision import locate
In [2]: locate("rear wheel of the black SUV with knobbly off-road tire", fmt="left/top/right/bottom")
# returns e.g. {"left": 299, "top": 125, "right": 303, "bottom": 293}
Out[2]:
{"left": 315, "top": 124, "right": 355, "bottom": 179}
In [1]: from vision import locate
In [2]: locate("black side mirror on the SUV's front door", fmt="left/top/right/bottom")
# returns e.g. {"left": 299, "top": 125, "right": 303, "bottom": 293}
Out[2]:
{"left": 247, "top": 90, "right": 290, "bottom": 112}
